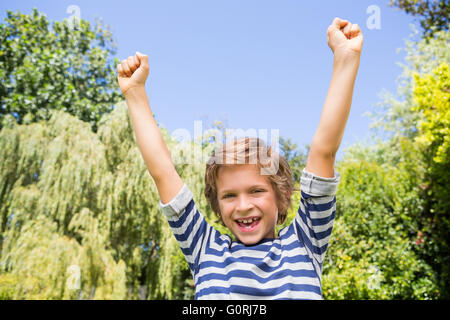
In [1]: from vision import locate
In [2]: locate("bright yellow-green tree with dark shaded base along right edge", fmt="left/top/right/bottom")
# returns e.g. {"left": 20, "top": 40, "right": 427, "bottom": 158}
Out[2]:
{"left": 412, "top": 63, "right": 450, "bottom": 298}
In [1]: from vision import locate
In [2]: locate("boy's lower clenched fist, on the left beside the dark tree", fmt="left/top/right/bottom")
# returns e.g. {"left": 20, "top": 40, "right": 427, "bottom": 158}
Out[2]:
{"left": 117, "top": 52, "right": 149, "bottom": 96}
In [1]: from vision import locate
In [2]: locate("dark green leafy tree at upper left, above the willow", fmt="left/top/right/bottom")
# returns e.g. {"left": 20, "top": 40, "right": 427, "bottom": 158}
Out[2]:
{"left": 0, "top": 9, "right": 120, "bottom": 131}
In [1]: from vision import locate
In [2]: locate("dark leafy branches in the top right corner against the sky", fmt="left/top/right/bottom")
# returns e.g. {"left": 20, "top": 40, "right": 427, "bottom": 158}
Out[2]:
{"left": 390, "top": 0, "right": 450, "bottom": 37}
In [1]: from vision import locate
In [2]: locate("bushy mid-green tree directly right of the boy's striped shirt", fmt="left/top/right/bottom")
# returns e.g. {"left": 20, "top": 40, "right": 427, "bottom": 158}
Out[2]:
{"left": 323, "top": 155, "right": 438, "bottom": 299}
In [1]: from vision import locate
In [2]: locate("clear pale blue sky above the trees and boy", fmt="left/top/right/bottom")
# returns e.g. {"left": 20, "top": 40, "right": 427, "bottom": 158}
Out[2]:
{"left": 0, "top": 0, "right": 418, "bottom": 160}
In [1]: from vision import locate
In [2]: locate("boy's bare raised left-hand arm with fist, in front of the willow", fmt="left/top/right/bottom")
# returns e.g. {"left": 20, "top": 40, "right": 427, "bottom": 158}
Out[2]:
{"left": 117, "top": 53, "right": 184, "bottom": 204}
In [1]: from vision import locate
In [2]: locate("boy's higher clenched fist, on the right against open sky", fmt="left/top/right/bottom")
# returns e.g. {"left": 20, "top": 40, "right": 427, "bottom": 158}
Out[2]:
{"left": 327, "top": 18, "right": 364, "bottom": 56}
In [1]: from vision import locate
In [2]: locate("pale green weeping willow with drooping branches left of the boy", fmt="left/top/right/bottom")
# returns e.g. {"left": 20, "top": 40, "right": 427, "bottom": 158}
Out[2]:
{"left": 0, "top": 103, "right": 218, "bottom": 299}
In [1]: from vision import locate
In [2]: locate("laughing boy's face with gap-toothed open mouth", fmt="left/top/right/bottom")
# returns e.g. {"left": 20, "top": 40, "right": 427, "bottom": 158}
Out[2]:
{"left": 217, "top": 164, "right": 278, "bottom": 245}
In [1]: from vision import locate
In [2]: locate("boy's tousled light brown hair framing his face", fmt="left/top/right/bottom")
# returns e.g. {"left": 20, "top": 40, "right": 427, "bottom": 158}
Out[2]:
{"left": 205, "top": 137, "right": 294, "bottom": 224}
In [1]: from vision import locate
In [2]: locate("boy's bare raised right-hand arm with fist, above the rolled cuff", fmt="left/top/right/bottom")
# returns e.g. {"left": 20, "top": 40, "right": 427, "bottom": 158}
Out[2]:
{"left": 306, "top": 18, "right": 363, "bottom": 178}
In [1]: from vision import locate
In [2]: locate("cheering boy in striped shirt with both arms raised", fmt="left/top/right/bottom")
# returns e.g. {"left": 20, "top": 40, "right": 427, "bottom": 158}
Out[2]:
{"left": 117, "top": 18, "right": 363, "bottom": 299}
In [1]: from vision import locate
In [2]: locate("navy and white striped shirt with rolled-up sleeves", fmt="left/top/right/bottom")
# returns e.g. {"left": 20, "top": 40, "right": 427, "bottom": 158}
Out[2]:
{"left": 159, "top": 169, "right": 340, "bottom": 299}
